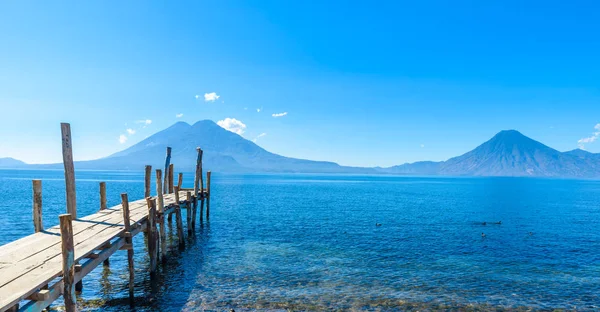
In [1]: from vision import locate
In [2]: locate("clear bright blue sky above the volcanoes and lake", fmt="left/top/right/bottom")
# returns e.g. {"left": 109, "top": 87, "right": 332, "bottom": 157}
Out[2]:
{"left": 0, "top": 0, "right": 600, "bottom": 166}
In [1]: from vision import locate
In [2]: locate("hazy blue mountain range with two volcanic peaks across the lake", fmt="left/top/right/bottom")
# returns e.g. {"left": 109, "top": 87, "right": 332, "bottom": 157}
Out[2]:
{"left": 0, "top": 120, "right": 600, "bottom": 178}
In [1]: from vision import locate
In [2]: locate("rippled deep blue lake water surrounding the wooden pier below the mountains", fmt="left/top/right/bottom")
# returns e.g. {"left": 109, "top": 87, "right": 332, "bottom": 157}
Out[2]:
{"left": 0, "top": 170, "right": 600, "bottom": 311}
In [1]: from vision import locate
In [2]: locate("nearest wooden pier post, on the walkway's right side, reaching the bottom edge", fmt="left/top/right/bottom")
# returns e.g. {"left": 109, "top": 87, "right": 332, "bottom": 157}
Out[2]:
{"left": 59, "top": 214, "right": 77, "bottom": 312}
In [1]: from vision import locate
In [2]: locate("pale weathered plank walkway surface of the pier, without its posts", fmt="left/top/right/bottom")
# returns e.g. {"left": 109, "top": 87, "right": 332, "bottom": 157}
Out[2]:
{"left": 0, "top": 191, "right": 206, "bottom": 311}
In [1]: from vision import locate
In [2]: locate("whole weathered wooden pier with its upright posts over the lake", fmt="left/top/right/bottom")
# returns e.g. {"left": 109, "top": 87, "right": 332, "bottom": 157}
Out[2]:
{"left": 0, "top": 124, "right": 210, "bottom": 312}
